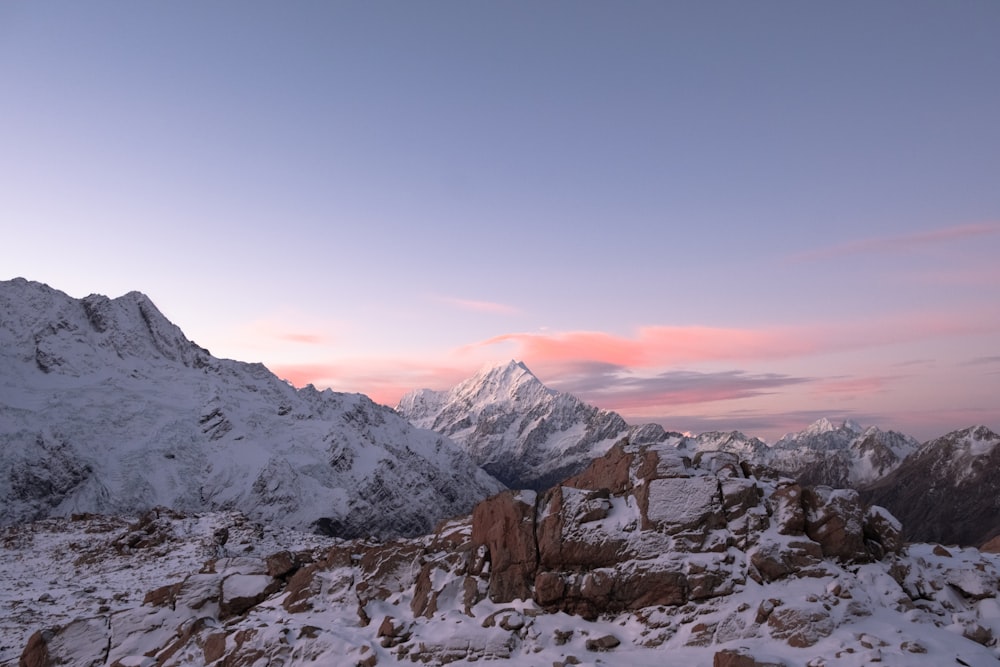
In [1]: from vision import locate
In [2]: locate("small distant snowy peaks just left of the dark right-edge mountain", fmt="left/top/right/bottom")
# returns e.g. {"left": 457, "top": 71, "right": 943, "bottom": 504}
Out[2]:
{"left": 765, "top": 419, "right": 920, "bottom": 488}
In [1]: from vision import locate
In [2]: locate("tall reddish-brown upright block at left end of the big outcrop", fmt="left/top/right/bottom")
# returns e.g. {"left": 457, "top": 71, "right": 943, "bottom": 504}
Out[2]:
{"left": 472, "top": 491, "right": 538, "bottom": 602}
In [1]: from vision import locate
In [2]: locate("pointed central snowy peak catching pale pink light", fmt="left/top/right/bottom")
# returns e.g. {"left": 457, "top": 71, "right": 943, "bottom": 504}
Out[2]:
{"left": 396, "top": 361, "right": 680, "bottom": 489}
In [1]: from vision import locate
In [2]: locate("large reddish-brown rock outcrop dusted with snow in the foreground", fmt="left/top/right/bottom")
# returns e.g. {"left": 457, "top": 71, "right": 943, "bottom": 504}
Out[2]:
{"left": 472, "top": 441, "right": 899, "bottom": 618}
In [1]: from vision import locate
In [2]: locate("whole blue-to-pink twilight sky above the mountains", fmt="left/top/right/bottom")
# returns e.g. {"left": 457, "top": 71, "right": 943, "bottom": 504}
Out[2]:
{"left": 0, "top": 0, "right": 1000, "bottom": 441}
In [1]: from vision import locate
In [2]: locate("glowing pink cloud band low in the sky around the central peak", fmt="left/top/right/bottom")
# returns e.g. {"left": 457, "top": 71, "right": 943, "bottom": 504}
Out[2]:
{"left": 272, "top": 313, "right": 1000, "bottom": 438}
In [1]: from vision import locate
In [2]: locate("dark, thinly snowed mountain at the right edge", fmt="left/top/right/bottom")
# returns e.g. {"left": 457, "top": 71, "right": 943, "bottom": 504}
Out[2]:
{"left": 862, "top": 426, "right": 1000, "bottom": 545}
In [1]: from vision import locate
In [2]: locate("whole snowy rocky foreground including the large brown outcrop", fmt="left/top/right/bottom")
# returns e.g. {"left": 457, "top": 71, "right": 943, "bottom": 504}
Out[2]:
{"left": 0, "top": 442, "right": 1000, "bottom": 667}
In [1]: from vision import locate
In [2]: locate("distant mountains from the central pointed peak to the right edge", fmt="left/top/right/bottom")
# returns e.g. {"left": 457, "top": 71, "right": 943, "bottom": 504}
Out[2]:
{"left": 397, "top": 361, "right": 1000, "bottom": 545}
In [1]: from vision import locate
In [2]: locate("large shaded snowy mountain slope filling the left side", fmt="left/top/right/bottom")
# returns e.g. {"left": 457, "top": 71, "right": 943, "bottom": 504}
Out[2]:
{"left": 0, "top": 279, "right": 502, "bottom": 536}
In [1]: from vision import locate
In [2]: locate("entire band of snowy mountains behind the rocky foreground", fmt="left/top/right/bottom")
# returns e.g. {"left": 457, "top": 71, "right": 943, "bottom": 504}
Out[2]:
{"left": 0, "top": 279, "right": 1000, "bottom": 545}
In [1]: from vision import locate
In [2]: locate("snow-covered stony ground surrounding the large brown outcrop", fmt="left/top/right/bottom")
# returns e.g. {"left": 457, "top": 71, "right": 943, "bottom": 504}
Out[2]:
{"left": 0, "top": 513, "right": 1000, "bottom": 667}
